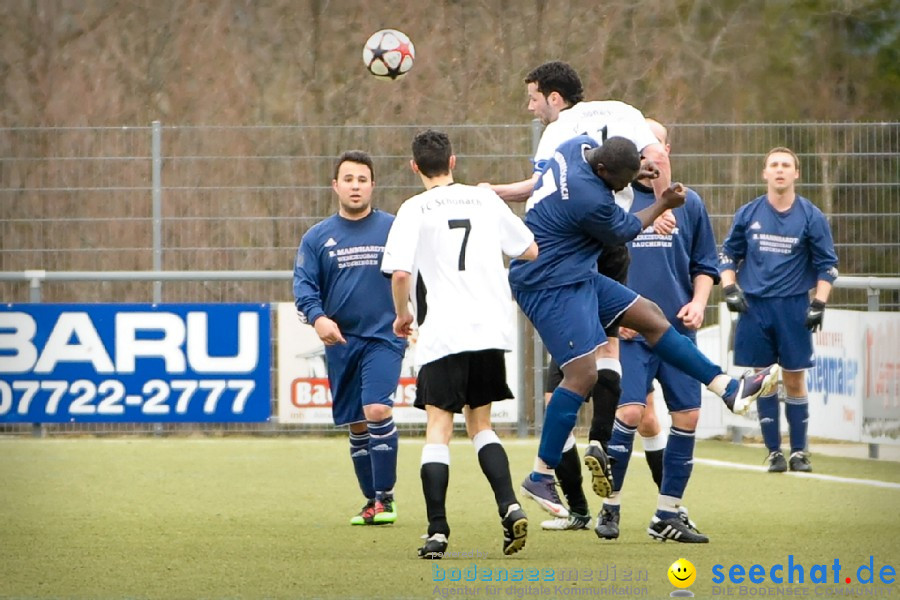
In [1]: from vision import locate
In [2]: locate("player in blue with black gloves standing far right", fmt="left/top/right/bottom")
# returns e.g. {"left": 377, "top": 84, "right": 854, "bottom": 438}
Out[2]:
{"left": 719, "top": 147, "right": 838, "bottom": 473}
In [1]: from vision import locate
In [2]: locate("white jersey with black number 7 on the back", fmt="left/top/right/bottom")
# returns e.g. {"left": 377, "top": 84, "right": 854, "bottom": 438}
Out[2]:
{"left": 381, "top": 184, "right": 534, "bottom": 367}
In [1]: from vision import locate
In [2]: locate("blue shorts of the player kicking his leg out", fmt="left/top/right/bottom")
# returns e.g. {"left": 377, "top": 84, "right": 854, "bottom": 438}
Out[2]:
{"left": 513, "top": 273, "right": 638, "bottom": 367}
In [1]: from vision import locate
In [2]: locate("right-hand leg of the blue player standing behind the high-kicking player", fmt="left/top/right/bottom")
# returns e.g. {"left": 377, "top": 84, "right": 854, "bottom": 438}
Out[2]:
{"left": 647, "top": 363, "right": 709, "bottom": 543}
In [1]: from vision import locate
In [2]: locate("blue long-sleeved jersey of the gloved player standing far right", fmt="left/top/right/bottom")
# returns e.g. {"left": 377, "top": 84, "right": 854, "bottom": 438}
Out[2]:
{"left": 719, "top": 195, "right": 837, "bottom": 298}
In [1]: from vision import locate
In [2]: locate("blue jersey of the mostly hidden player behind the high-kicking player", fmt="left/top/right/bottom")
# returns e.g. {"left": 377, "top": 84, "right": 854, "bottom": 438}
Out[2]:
{"left": 628, "top": 183, "right": 719, "bottom": 336}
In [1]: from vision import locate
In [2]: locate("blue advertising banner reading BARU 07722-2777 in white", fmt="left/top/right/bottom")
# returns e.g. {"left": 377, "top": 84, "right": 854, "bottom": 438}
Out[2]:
{"left": 0, "top": 304, "right": 272, "bottom": 423}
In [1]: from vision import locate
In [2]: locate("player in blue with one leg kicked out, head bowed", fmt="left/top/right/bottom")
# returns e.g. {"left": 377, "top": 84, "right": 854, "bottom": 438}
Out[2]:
{"left": 509, "top": 136, "right": 778, "bottom": 536}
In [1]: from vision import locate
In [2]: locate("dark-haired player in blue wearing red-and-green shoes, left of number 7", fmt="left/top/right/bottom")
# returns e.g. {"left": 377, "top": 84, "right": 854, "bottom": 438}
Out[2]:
{"left": 294, "top": 150, "right": 406, "bottom": 525}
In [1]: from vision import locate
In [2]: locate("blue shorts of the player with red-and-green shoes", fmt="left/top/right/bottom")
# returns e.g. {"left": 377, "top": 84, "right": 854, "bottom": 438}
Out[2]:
{"left": 325, "top": 335, "right": 403, "bottom": 425}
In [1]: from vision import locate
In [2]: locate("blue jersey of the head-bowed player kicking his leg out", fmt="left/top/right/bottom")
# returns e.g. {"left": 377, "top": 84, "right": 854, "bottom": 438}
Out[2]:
{"left": 509, "top": 135, "right": 641, "bottom": 290}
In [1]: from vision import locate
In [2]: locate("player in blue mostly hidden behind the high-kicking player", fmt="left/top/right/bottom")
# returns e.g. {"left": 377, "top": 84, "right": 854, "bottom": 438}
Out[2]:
{"left": 594, "top": 119, "right": 719, "bottom": 543}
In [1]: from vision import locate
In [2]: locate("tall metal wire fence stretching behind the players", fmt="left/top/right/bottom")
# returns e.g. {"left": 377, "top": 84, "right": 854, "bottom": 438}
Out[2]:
{"left": 0, "top": 123, "right": 900, "bottom": 433}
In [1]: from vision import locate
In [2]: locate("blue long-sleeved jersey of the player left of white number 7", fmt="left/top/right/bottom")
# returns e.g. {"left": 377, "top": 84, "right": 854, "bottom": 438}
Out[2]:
{"left": 294, "top": 210, "right": 405, "bottom": 348}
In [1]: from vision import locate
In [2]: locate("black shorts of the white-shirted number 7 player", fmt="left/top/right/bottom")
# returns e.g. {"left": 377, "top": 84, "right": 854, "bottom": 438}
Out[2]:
{"left": 414, "top": 350, "right": 514, "bottom": 413}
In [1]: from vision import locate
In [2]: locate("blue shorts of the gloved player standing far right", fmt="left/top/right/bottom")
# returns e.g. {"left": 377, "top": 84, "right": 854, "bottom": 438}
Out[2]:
{"left": 734, "top": 294, "right": 815, "bottom": 371}
